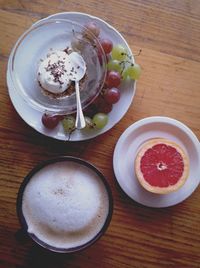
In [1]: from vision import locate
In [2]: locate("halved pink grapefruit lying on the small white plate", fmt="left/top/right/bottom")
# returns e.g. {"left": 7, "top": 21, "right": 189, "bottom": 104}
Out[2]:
{"left": 135, "top": 138, "right": 189, "bottom": 194}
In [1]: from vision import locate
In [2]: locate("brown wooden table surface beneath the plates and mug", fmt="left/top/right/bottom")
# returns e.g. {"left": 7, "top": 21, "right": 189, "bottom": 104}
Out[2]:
{"left": 0, "top": 0, "right": 200, "bottom": 268}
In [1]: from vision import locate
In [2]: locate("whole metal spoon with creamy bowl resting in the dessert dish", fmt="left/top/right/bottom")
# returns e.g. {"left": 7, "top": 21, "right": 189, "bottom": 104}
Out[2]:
{"left": 69, "top": 52, "right": 86, "bottom": 129}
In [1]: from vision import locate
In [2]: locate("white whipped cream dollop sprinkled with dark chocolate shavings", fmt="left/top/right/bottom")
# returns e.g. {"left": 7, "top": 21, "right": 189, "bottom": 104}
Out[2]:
{"left": 38, "top": 50, "right": 86, "bottom": 94}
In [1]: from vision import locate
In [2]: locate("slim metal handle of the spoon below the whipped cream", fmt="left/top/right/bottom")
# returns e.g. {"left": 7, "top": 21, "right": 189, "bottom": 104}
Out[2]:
{"left": 75, "top": 81, "right": 86, "bottom": 129}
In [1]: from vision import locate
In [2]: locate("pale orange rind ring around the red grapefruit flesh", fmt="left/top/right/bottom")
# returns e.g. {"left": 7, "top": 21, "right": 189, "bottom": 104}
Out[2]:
{"left": 135, "top": 138, "right": 189, "bottom": 194}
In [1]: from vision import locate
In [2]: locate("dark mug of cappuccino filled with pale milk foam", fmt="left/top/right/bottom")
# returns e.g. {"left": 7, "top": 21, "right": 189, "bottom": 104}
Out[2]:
{"left": 17, "top": 157, "right": 113, "bottom": 253}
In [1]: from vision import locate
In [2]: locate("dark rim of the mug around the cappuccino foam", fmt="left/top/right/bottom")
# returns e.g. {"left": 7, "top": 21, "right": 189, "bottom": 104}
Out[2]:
{"left": 16, "top": 156, "right": 113, "bottom": 253}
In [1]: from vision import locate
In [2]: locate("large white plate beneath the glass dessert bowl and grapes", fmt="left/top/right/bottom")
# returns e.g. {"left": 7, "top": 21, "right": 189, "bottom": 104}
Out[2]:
{"left": 7, "top": 12, "right": 136, "bottom": 141}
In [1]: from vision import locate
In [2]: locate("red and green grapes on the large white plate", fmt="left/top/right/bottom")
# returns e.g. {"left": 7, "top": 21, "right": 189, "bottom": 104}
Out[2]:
{"left": 42, "top": 21, "right": 141, "bottom": 133}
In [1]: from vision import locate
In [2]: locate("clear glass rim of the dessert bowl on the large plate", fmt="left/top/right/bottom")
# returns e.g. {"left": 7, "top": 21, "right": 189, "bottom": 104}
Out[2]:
{"left": 8, "top": 18, "right": 107, "bottom": 114}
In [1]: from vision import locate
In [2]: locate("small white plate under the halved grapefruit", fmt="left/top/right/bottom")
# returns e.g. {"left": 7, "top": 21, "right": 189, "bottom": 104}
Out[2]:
{"left": 113, "top": 117, "right": 200, "bottom": 208}
